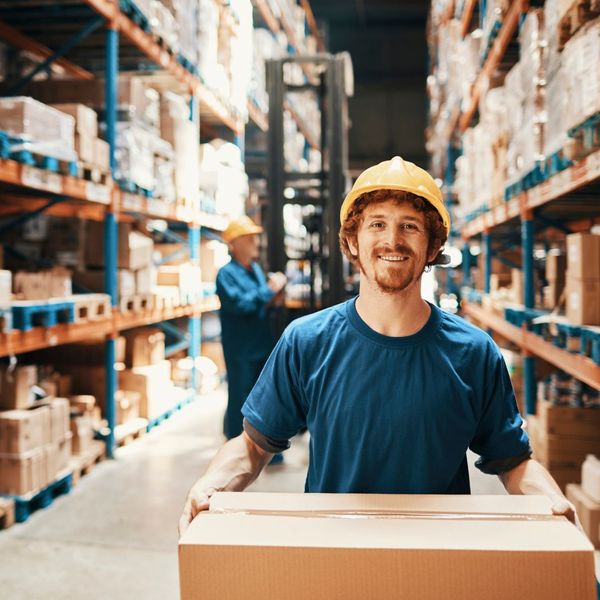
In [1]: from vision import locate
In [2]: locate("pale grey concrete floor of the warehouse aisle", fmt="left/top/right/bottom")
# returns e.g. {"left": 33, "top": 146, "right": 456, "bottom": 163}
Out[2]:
{"left": 0, "top": 390, "right": 596, "bottom": 600}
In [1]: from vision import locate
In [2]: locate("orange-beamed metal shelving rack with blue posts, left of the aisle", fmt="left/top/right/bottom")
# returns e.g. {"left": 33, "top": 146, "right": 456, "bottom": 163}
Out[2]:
{"left": 0, "top": 0, "right": 258, "bottom": 456}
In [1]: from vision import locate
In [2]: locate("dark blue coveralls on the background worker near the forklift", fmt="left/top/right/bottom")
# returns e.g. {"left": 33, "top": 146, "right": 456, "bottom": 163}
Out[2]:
{"left": 217, "top": 259, "right": 274, "bottom": 439}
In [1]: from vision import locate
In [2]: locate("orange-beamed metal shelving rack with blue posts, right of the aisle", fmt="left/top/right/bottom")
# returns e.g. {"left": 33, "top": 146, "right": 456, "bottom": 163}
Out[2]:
{"left": 428, "top": 0, "right": 600, "bottom": 414}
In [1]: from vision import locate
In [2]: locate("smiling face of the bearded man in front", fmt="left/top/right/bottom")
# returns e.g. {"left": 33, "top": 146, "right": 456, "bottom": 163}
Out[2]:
{"left": 348, "top": 199, "right": 438, "bottom": 294}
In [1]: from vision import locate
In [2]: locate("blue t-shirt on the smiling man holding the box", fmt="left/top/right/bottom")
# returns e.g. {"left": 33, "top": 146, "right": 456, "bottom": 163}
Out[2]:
{"left": 242, "top": 299, "right": 531, "bottom": 494}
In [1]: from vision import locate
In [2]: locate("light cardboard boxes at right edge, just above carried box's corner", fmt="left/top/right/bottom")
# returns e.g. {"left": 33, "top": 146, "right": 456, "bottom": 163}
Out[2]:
{"left": 567, "top": 454, "right": 600, "bottom": 548}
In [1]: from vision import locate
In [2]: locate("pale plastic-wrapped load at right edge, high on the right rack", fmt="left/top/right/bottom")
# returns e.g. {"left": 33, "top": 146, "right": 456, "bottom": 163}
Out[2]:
{"left": 563, "top": 18, "right": 600, "bottom": 128}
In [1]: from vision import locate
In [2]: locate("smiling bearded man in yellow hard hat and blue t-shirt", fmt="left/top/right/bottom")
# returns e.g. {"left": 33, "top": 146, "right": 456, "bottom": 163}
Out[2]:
{"left": 180, "top": 157, "right": 576, "bottom": 531}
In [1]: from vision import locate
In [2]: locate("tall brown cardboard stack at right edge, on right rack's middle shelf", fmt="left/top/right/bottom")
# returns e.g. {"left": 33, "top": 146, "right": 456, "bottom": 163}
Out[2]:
{"left": 567, "top": 233, "right": 600, "bottom": 325}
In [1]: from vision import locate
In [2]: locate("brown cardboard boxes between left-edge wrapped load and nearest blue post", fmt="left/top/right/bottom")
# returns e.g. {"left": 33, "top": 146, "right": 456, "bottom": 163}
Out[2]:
{"left": 51, "top": 103, "right": 110, "bottom": 173}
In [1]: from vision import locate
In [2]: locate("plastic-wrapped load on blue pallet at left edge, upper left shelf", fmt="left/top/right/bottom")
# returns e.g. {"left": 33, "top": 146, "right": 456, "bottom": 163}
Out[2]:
{"left": 0, "top": 96, "right": 77, "bottom": 161}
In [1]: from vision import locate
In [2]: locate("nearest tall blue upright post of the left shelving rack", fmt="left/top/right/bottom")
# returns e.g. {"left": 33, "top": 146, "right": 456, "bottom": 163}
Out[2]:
{"left": 104, "top": 25, "right": 119, "bottom": 458}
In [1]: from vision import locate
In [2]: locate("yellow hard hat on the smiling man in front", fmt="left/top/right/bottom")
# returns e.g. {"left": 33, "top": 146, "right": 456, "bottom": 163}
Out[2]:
{"left": 340, "top": 156, "right": 450, "bottom": 235}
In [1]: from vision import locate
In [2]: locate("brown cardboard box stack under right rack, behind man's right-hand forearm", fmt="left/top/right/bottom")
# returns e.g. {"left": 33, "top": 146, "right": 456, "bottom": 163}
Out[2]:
{"left": 527, "top": 399, "right": 600, "bottom": 490}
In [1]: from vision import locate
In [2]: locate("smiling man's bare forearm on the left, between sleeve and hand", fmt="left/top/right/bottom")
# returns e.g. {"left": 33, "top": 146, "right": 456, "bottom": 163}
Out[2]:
{"left": 201, "top": 432, "right": 273, "bottom": 492}
